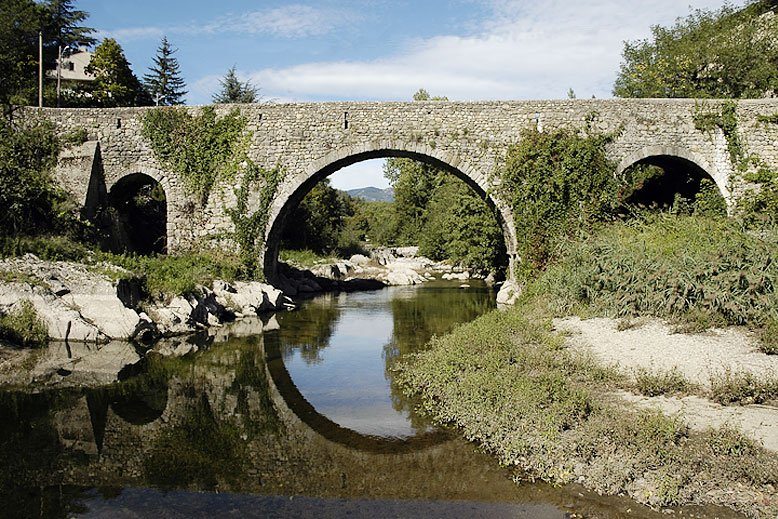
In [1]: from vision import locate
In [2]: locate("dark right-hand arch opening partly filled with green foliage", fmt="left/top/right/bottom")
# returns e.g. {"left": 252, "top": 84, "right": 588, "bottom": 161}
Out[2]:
{"left": 622, "top": 155, "right": 727, "bottom": 215}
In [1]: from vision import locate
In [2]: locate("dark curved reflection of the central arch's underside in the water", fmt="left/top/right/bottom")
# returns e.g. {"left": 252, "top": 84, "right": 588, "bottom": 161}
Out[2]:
{"left": 263, "top": 333, "right": 452, "bottom": 454}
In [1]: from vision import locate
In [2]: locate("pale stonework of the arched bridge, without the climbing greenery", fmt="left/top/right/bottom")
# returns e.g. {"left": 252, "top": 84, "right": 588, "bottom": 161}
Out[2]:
{"left": 43, "top": 99, "right": 778, "bottom": 276}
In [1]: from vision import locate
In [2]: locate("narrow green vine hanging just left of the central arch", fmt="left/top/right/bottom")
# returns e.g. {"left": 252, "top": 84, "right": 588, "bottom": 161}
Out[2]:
{"left": 226, "top": 162, "right": 283, "bottom": 277}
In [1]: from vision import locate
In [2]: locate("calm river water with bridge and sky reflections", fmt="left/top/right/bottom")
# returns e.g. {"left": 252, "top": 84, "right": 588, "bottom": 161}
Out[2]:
{"left": 0, "top": 282, "right": 744, "bottom": 519}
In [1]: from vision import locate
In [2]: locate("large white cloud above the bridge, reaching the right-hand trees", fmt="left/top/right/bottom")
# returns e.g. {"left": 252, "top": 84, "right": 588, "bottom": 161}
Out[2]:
{"left": 242, "top": 0, "right": 744, "bottom": 100}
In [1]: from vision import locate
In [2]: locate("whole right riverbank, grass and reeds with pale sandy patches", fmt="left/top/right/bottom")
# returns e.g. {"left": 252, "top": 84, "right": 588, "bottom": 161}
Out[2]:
{"left": 399, "top": 217, "right": 778, "bottom": 517}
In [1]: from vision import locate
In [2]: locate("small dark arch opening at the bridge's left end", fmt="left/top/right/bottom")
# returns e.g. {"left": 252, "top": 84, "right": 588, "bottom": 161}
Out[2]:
{"left": 108, "top": 173, "right": 167, "bottom": 255}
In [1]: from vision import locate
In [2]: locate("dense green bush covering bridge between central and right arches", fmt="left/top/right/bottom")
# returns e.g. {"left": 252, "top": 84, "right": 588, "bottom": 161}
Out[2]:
{"left": 498, "top": 128, "right": 627, "bottom": 276}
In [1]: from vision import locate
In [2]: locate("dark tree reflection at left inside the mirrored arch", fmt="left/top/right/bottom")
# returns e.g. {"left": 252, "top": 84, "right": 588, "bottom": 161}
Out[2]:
{"left": 274, "top": 294, "right": 341, "bottom": 364}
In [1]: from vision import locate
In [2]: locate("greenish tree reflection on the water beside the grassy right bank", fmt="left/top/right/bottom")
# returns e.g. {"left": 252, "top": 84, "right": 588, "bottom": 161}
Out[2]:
{"left": 383, "top": 286, "right": 495, "bottom": 430}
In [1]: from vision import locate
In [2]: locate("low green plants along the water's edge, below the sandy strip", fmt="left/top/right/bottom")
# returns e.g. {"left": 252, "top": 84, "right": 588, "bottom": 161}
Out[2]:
{"left": 398, "top": 296, "right": 778, "bottom": 516}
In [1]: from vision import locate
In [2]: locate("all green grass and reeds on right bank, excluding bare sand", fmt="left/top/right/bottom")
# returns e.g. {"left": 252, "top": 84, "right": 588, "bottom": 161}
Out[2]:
{"left": 398, "top": 215, "right": 778, "bottom": 517}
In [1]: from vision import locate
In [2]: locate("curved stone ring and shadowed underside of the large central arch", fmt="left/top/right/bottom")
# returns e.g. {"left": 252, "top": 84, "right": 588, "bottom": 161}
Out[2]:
{"left": 262, "top": 143, "right": 516, "bottom": 281}
